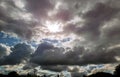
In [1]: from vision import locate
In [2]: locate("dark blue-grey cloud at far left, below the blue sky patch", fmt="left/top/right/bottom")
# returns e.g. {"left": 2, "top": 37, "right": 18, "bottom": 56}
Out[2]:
{"left": 0, "top": 43, "right": 34, "bottom": 65}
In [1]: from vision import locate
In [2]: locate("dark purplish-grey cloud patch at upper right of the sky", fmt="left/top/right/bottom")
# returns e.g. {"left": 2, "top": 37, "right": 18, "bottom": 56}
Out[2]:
{"left": 81, "top": 3, "right": 119, "bottom": 35}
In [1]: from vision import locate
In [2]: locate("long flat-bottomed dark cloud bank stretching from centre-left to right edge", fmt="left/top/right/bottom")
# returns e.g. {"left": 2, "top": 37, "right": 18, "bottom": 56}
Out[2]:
{"left": 30, "top": 41, "right": 120, "bottom": 66}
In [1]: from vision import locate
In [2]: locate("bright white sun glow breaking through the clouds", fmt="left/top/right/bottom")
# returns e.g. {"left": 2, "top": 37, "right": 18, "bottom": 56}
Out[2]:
{"left": 45, "top": 21, "right": 63, "bottom": 33}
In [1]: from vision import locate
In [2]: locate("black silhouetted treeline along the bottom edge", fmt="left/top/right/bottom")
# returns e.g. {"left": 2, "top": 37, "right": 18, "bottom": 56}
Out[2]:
{"left": 0, "top": 65, "right": 120, "bottom": 77}
